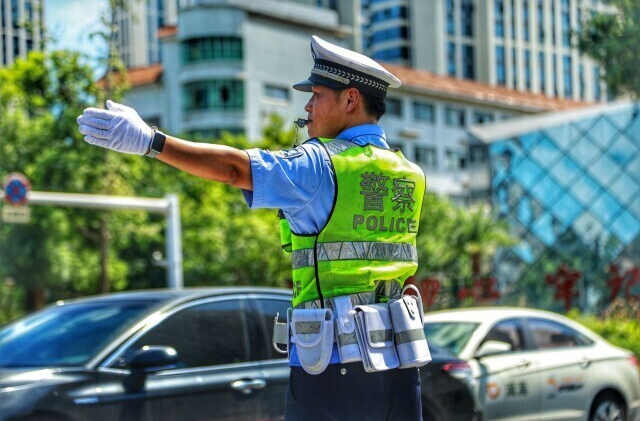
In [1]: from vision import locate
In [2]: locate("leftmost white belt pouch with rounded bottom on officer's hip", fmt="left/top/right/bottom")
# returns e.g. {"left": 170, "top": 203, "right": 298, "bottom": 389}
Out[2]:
{"left": 291, "top": 308, "right": 333, "bottom": 374}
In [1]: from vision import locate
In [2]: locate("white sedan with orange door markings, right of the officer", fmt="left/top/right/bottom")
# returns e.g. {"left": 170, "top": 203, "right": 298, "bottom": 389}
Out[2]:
{"left": 424, "top": 307, "right": 640, "bottom": 421}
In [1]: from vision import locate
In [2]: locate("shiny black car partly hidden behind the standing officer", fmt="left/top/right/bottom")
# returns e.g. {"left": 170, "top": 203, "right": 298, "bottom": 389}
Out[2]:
{"left": 0, "top": 288, "right": 475, "bottom": 421}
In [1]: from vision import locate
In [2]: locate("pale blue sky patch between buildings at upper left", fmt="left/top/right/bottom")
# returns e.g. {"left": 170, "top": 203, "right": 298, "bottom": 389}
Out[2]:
{"left": 44, "top": 0, "right": 108, "bottom": 68}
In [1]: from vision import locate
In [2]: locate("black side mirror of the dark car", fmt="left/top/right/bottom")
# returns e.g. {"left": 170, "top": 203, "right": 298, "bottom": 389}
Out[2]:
{"left": 124, "top": 345, "right": 178, "bottom": 393}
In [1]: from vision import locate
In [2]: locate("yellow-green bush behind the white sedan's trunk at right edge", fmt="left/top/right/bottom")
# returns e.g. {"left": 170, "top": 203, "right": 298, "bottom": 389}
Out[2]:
{"left": 567, "top": 299, "right": 640, "bottom": 358}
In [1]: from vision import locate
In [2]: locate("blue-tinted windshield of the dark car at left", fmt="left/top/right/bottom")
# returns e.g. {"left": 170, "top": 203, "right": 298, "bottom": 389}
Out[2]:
{"left": 0, "top": 301, "right": 155, "bottom": 367}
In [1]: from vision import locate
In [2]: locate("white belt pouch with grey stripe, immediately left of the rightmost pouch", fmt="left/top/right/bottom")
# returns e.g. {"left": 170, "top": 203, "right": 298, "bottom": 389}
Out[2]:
{"left": 354, "top": 303, "right": 400, "bottom": 373}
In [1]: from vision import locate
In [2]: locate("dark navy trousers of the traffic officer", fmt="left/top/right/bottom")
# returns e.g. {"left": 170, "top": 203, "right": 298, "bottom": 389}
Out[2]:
{"left": 285, "top": 363, "right": 422, "bottom": 421}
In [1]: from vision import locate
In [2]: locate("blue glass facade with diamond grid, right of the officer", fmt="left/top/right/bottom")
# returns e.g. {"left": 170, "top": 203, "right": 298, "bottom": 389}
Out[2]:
{"left": 488, "top": 105, "right": 640, "bottom": 308}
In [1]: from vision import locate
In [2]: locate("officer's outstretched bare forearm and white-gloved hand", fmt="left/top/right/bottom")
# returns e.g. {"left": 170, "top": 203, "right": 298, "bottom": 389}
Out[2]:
{"left": 78, "top": 101, "right": 253, "bottom": 190}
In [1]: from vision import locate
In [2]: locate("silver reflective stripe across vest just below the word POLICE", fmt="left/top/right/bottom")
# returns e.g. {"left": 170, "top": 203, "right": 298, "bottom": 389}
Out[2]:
{"left": 292, "top": 241, "right": 418, "bottom": 269}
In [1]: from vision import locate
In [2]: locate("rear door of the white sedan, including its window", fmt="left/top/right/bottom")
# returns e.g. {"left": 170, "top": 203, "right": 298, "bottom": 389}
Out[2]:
{"left": 526, "top": 318, "right": 594, "bottom": 421}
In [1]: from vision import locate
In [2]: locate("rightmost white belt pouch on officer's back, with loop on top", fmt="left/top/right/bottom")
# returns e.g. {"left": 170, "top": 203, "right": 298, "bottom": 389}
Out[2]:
{"left": 389, "top": 285, "right": 431, "bottom": 368}
